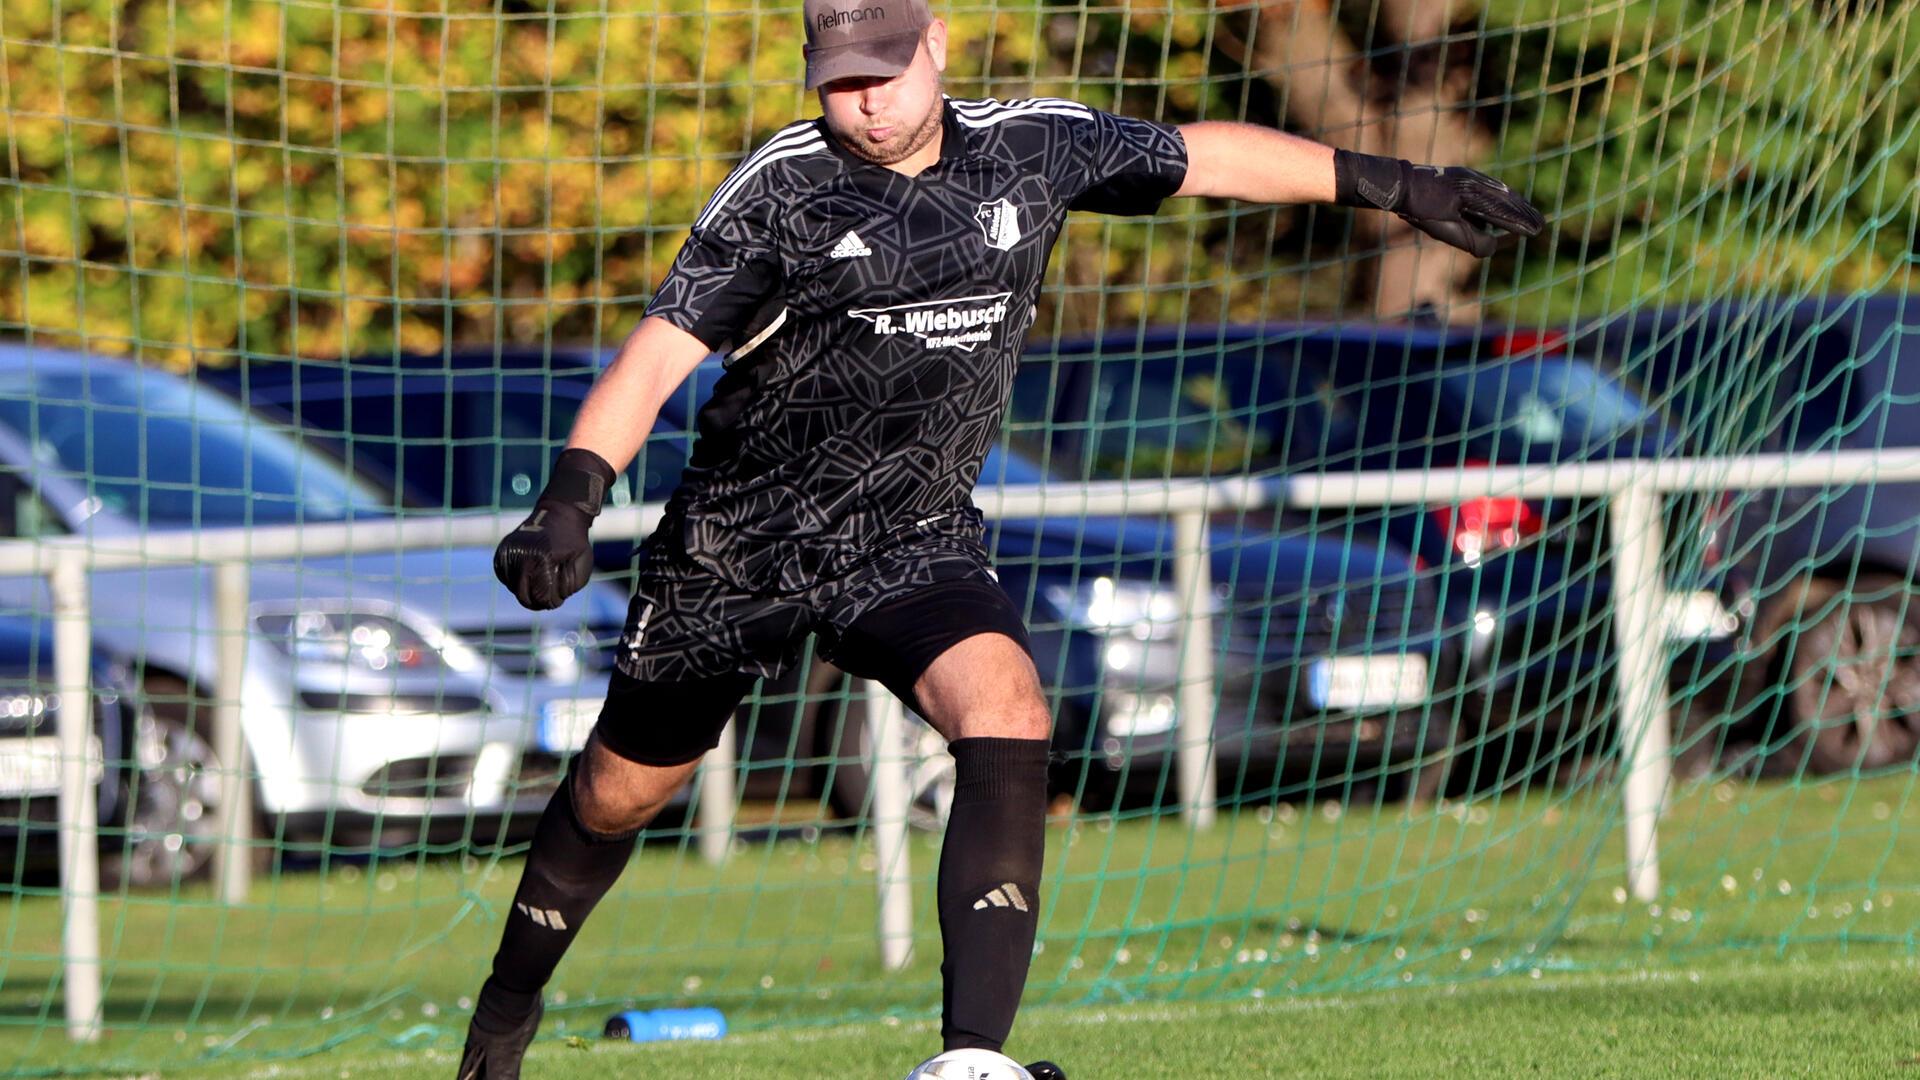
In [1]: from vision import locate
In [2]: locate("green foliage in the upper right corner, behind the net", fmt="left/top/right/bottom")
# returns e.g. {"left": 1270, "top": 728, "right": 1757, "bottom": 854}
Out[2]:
{"left": 1484, "top": 0, "right": 1920, "bottom": 317}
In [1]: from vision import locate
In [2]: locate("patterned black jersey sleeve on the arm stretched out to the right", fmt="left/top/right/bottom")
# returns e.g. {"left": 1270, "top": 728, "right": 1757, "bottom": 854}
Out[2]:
{"left": 1056, "top": 108, "right": 1187, "bottom": 213}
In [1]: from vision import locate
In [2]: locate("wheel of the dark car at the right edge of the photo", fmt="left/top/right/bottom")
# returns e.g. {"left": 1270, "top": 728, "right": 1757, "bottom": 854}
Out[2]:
{"left": 1788, "top": 580, "right": 1920, "bottom": 773}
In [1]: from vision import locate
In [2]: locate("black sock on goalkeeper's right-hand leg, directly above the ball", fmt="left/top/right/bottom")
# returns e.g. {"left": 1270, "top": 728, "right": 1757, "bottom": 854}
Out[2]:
{"left": 937, "top": 738, "right": 1048, "bottom": 1051}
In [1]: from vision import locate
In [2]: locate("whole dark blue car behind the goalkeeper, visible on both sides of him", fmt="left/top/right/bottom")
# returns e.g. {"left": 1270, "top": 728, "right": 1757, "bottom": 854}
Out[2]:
{"left": 211, "top": 346, "right": 1442, "bottom": 807}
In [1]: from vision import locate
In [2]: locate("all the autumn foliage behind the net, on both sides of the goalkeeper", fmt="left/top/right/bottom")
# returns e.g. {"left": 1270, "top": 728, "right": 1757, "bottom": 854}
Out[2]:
{"left": 0, "top": 0, "right": 1920, "bottom": 363}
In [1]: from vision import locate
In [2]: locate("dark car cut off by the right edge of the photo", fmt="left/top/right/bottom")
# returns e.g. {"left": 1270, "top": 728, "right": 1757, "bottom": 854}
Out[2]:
{"left": 1582, "top": 294, "right": 1920, "bottom": 773}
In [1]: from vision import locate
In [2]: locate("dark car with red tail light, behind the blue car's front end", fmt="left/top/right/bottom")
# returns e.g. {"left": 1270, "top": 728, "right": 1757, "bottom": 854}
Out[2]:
{"left": 1010, "top": 325, "right": 1741, "bottom": 782}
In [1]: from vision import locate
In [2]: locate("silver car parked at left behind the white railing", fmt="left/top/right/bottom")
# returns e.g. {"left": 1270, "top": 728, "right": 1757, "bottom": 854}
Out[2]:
{"left": 0, "top": 346, "right": 626, "bottom": 876}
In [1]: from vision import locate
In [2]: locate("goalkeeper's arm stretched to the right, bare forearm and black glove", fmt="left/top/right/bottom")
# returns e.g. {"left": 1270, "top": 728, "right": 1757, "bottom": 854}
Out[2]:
{"left": 1173, "top": 121, "right": 1546, "bottom": 258}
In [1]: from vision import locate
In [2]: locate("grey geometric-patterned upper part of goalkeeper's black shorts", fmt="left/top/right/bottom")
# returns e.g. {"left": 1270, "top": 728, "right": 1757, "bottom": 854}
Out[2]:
{"left": 616, "top": 507, "right": 998, "bottom": 682}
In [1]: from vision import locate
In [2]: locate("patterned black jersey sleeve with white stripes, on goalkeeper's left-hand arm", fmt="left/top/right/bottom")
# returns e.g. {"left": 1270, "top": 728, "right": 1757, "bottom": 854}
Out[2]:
{"left": 647, "top": 158, "right": 781, "bottom": 352}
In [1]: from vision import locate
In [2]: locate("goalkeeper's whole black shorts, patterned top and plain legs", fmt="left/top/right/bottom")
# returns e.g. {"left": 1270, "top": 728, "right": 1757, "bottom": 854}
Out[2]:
{"left": 593, "top": 538, "right": 1033, "bottom": 765}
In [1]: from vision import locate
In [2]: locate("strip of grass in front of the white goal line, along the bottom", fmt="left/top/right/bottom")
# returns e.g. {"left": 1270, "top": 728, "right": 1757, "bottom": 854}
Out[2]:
{"left": 196, "top": 957, "right": 1920, "bottom": 1080}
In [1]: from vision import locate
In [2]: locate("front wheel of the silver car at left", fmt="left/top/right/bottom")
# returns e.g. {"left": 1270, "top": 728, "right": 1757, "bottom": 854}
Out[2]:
{"left": 111, "top": 675, "right": 221, "bottom": 886}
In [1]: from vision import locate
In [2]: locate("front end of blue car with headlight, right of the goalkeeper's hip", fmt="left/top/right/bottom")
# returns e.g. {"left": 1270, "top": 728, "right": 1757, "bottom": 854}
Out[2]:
{"left": 981, "top": 438, "right": 1455, "bottom": 801}
